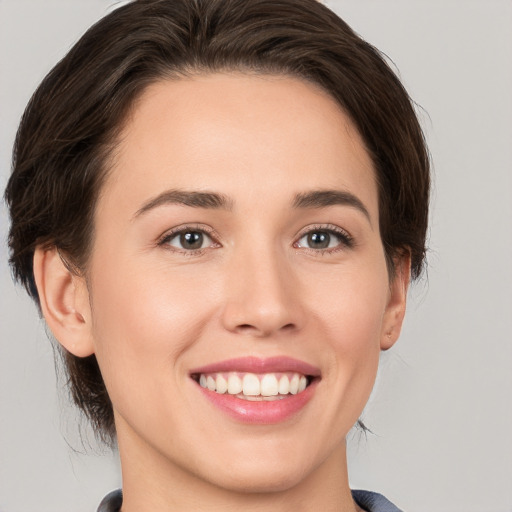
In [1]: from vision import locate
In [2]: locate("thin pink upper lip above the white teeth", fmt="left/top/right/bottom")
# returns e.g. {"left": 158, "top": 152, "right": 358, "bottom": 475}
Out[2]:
{"left": 190, "top": 356, "right": 321, "bottom": 377}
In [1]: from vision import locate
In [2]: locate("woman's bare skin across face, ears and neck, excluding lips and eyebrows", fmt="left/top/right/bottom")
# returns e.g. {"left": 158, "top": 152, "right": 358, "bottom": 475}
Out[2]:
{"left": 34, "top": 73, "right": 409, "bottom": 512}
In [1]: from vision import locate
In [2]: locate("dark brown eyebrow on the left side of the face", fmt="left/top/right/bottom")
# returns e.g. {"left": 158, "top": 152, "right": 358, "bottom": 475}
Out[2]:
{"left": 134, "top": 190, "right": 233, "bottom": 218}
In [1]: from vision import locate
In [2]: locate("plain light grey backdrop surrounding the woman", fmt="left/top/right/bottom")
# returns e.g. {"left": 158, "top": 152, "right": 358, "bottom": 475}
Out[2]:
{"left": 0, "top": 0, "right": 512, "bottom": 512}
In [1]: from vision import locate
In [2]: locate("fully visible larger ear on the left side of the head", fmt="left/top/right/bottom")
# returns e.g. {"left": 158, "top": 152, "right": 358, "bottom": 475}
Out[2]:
{"left": 34, "top": 247, "right": 94, "bottom": 357}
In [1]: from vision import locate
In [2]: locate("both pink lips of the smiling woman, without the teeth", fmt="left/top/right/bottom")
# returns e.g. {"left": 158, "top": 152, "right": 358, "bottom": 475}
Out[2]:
{"left": 190, "top": 356, "right": 320, "bottom": 425}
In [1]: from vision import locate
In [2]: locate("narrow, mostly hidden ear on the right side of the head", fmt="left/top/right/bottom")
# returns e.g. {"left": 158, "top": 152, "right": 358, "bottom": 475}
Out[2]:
{"left": 380, "top": 251, "right": 411, "bottom": 350}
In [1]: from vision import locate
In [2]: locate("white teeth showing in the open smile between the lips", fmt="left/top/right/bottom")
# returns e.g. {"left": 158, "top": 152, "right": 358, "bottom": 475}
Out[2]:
{"left": 191, "top": 371, "right": 315, "bottom": 401}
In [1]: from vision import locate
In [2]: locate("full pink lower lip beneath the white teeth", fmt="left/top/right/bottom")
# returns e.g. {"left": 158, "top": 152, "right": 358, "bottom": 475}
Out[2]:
{"left": 197, "top": 379, "right": 318, "bottom": 425}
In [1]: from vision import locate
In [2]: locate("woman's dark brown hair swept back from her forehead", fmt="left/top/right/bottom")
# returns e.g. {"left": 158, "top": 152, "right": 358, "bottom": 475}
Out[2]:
{"left": 5, "top": 0, "right": 430, "bottom": 441}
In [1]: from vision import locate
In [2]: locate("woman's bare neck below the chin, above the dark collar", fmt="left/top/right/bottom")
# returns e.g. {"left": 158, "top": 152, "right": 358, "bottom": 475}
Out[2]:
{"left": 118, "top": 418, "right": 361, "bottom": 512}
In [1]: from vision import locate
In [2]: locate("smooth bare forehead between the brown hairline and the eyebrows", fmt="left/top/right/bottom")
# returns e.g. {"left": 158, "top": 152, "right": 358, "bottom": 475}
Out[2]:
{"left": 99, "top": 73, "right": 377, "bottom": 215}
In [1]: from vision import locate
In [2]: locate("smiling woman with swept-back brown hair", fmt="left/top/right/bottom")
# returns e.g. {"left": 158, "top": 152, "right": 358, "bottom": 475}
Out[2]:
{"left": 6, "top": 0, "right": 429, "bottom": 512}
